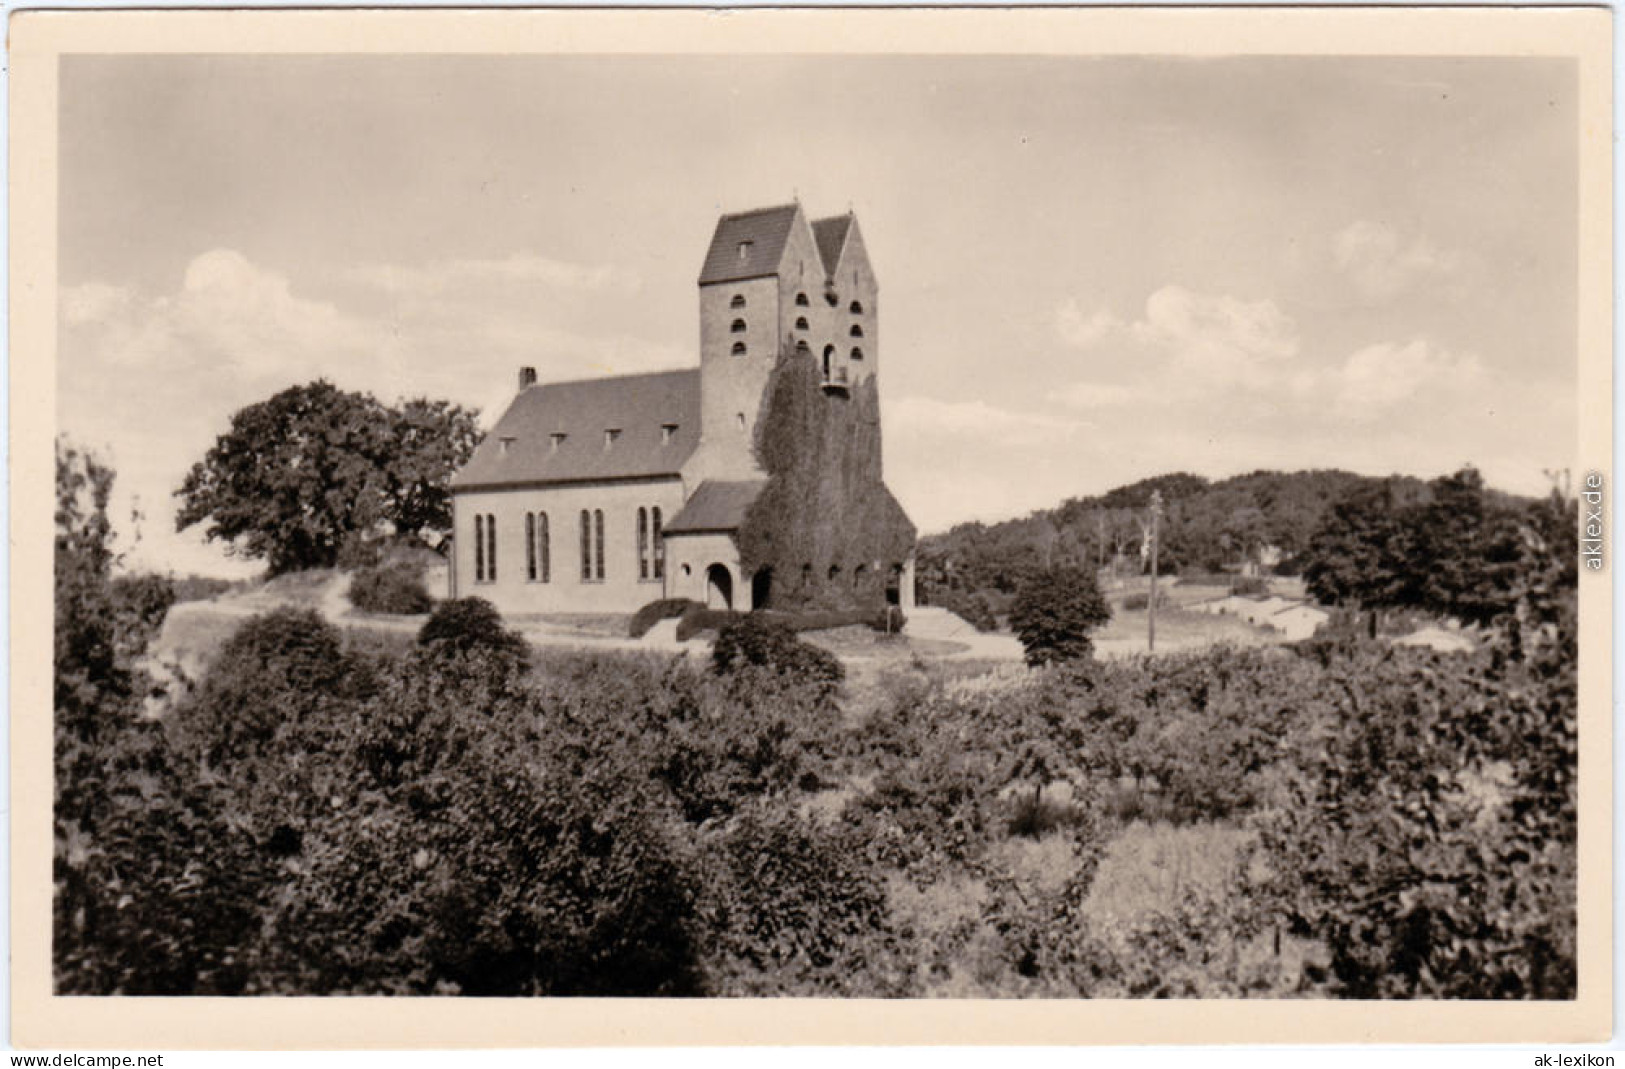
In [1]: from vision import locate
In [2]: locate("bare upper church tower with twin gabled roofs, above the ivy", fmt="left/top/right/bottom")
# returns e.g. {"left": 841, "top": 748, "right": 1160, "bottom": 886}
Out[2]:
{"left": 687, "top": 203, "right": 879, "bottom": 484}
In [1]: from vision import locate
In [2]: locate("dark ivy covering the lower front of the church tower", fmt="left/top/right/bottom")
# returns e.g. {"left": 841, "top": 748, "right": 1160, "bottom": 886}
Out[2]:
{"left": 739, "top": 342, "right": 915, "bottom": 609}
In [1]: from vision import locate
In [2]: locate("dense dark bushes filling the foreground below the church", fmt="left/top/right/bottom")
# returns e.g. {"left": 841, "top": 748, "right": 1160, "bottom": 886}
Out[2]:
{"left": 63, "top": 454, "right": 1576, "bottom": 999}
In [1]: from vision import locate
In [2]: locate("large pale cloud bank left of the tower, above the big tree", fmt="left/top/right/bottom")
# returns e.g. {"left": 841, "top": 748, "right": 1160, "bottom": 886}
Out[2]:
{"left": 57, "top": 249, "right": 694, "bottom": 572}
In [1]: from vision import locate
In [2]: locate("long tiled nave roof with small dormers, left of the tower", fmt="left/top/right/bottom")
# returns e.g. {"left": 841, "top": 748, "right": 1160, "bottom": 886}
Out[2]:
{"left": 452, "top": 367, "right": 700, "bottom": 491}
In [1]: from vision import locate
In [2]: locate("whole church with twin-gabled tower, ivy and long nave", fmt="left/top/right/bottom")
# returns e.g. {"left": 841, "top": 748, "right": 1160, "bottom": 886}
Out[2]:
{"left": 450, "top": 203, "right": 913, "bottom": 614}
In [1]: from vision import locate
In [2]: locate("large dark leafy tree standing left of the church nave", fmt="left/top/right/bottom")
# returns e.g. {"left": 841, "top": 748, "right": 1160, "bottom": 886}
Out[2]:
{"left": 176, "top": 380, "right": 479, "bottom": 573}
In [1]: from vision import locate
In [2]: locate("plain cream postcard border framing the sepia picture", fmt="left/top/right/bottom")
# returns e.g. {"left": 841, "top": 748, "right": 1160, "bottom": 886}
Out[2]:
{"left": 10, "top": 8, "right": 1615, "bottom": 1050}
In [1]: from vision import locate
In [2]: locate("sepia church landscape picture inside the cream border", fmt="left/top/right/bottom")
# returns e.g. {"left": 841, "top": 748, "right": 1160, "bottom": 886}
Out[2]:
{"left": 11, "top": 2, "right": 1614, "bottom": 1038}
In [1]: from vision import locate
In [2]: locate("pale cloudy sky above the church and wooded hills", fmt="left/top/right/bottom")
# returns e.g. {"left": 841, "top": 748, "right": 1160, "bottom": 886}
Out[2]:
{"left": 57, "top": 55, "right": 1578, "bottom": 575}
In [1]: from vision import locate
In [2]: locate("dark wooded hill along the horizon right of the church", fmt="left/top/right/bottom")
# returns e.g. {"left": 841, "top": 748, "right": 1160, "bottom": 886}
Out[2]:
{"left": 918, "top": 468, "right": 1549, "bottom": 619}
